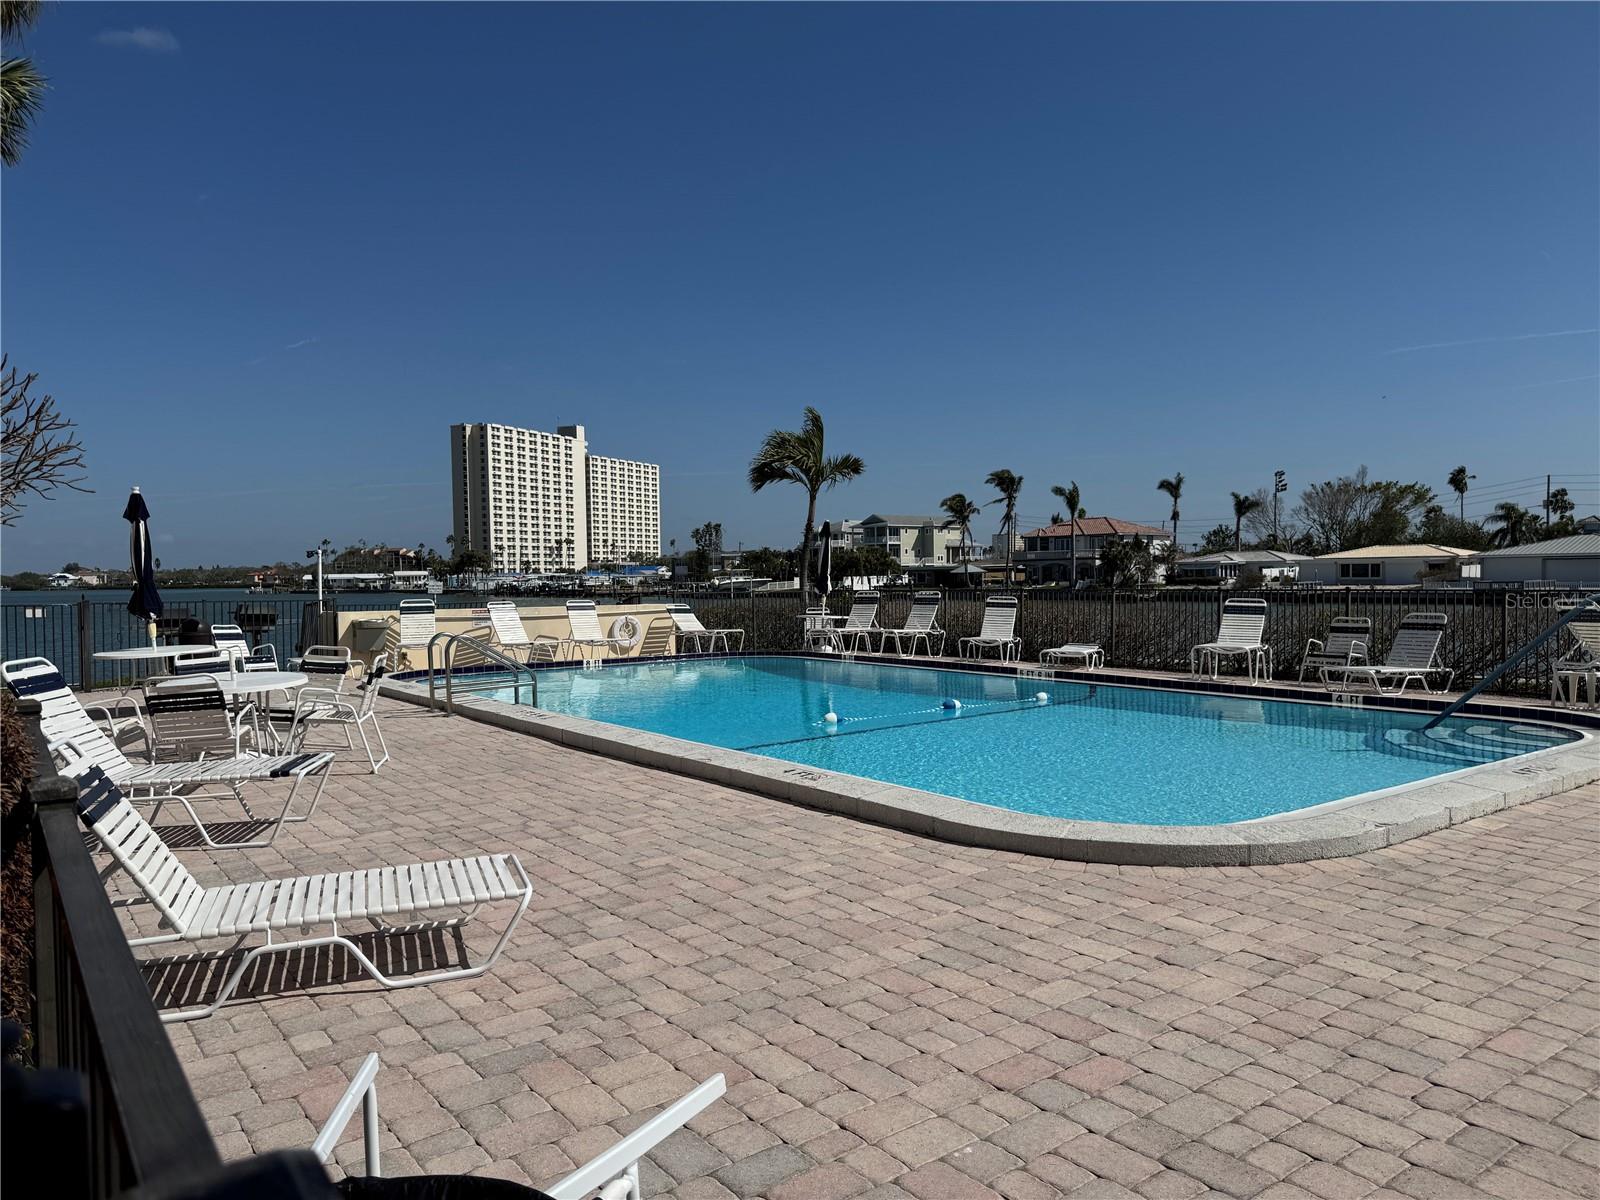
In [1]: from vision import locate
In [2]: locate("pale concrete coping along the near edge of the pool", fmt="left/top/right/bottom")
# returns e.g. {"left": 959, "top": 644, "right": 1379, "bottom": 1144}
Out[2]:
{"left": 381, "top": 680, "right": 1600, "bottom": 867}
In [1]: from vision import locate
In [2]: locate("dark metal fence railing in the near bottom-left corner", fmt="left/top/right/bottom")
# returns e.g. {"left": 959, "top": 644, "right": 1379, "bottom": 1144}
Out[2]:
{"left": 6, "top": 699, "right": 219, "bottom": 1197}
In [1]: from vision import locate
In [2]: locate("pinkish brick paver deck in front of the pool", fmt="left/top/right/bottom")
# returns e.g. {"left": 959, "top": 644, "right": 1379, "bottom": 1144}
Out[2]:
{"left": 158, "top": 701, "right": 1600, "bottom": 1200}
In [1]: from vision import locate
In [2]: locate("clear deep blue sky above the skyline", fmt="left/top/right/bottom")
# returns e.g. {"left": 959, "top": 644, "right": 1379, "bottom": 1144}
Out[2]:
{"left": 3, "top": 3, "right": 1600, "bottom": 571}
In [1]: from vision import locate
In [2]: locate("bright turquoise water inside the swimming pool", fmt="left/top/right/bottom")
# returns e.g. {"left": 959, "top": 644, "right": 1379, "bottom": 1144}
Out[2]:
{"left": 473, "top": 658, "right": 1576, "bottom": 826}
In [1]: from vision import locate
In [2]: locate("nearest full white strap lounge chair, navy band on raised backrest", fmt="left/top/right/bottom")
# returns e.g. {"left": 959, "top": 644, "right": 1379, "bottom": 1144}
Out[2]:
{"left": 77, "top": 766, "right": 533, "bottom": 1022}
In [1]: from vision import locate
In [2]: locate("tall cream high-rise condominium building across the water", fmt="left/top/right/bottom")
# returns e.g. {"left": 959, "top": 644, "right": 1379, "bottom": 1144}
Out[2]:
{"left": 450, "top": 424, "right": 661, "bottom": 571}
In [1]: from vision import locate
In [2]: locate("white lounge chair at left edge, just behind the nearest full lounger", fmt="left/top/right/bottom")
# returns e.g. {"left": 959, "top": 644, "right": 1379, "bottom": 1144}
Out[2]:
{"left": 0, "top": 658, "right": 333, "bottom": 850}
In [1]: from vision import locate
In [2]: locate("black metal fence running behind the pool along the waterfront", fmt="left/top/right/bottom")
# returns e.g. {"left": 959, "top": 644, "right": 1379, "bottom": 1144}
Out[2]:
{"left": 3, "top": 587, "right": 1573, "bottom": 694}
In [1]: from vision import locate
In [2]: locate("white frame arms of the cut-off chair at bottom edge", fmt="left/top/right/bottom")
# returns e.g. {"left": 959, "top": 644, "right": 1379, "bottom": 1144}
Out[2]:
{"left": 310, "top": 1053, "right": 728, "bottom": 1200}
